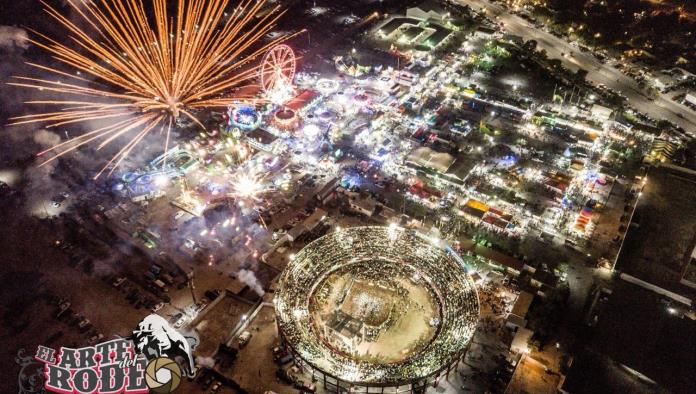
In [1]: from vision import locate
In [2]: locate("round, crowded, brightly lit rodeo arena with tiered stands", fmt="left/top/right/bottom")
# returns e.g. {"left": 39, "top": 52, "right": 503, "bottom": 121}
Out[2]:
{"left": 274, "top": 226, "right": 479, "bottom": 393}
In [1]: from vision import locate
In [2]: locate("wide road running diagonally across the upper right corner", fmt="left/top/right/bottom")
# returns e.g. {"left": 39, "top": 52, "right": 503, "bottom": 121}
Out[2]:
{"left": 457, "top": 0, "right": 696, "bottom": 136}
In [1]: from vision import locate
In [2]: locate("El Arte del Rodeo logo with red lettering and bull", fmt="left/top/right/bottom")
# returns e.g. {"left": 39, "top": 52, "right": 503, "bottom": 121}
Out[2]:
{"left": 34, "top": 314, "right": 197, "bottom": 394}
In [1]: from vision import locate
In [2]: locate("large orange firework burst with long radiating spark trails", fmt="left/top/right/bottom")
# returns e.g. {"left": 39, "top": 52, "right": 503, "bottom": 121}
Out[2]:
{"left": 9, "top": 0, "right": 302, "bottom": 178}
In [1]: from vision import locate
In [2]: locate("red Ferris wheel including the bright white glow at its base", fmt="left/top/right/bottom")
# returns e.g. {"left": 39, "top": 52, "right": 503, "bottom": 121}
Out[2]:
{"left": 259, "top": 44, "right": 296, "bottom": 105}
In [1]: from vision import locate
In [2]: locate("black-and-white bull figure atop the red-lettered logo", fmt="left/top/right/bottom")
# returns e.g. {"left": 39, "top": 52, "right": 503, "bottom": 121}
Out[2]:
{"left": 128, "top": 314, "right": 196, "bottom": 377}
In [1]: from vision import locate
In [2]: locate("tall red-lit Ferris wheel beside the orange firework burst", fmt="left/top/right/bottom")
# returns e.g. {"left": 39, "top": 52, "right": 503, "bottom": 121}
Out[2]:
{"left": 260, "top": 44, "right": 295, "bottom": 93}
